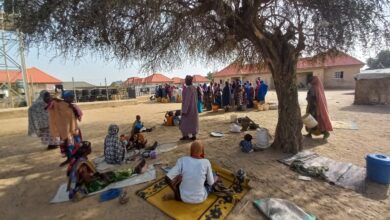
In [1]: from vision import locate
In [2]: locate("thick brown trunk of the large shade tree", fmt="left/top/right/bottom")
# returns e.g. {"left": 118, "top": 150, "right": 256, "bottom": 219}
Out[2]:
{"left": 272, "top": 56, "right": 303, "bottom": 153}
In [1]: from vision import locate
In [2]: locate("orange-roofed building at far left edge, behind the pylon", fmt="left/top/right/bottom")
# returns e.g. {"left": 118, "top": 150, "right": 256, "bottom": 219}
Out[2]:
{"left": 0, "top": 67, "right": 62, "bottom": 97}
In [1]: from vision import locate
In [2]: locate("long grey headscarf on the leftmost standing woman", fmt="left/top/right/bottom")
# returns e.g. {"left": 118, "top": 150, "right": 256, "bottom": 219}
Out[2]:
{"left": 28, "top": 90, "right": 49, "bottom": 136}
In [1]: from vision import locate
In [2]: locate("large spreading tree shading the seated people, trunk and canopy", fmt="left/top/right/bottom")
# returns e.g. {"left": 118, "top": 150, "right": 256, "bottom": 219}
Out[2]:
{"left": 12, "top": 0, "right": 390, "bottom": 152}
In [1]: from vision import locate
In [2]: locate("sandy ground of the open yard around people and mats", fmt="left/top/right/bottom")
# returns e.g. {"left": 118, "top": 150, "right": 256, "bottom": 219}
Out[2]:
{"left": 0, "top": 91, "right": 390, "bottom": 219}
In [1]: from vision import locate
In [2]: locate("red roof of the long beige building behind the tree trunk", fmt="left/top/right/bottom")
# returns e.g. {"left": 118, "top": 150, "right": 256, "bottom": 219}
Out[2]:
{"left": 215, "top": 53, "right": 364, "bottom": 77}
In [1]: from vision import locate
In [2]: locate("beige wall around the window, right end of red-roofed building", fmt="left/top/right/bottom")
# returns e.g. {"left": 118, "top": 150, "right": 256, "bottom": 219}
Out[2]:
{"left": 323, "top": 66, "right": 361, "bottom": 89}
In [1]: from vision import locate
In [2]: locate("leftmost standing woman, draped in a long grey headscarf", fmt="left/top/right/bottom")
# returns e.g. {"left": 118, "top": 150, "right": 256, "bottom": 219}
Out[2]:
{"left": 28, "top": 90, "right": 60, "bottom": 150}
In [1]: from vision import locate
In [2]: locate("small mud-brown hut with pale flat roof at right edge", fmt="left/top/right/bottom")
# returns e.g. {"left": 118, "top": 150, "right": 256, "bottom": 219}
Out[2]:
{"left": 355, "top": 68, "right": 390, "bottom": 105}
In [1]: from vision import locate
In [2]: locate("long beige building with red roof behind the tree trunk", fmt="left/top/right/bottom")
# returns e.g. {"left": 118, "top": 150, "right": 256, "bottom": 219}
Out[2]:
{"left": 214, "top": 53, "right": 364, "bottom": 89}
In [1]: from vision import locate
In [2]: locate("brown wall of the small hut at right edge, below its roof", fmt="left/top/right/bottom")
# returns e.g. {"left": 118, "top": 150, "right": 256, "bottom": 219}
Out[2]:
{"left": 355, "top": 78, "right": 390, "bottom": 105}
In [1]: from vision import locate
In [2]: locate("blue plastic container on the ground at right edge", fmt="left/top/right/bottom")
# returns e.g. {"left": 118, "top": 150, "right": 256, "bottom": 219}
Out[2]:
{"left": 366, "top": 154, "right": 390, "bottom": 184}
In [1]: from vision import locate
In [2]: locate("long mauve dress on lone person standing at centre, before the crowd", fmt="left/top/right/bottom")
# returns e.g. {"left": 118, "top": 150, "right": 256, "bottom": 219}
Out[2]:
{"left": 180, "top": 85, "right": 199, "bottom": 136}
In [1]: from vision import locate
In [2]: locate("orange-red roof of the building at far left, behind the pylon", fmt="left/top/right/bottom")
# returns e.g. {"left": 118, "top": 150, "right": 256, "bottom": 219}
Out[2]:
{"left": 0, "top": 67, "right": 61, "bottom": 84}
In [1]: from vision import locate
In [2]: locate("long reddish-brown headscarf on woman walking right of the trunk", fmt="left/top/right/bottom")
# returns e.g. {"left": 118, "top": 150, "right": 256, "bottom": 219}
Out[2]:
{"left": 311, "top": 76, "right": 333, "bottom": 131}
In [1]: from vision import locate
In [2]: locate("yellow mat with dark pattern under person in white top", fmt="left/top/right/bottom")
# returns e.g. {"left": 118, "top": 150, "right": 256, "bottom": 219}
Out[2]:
{"left": 137, "top": 164, "right": 250, "bottom": 220}
